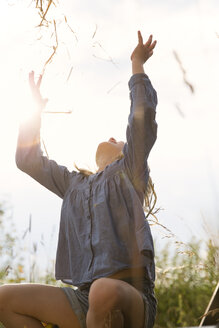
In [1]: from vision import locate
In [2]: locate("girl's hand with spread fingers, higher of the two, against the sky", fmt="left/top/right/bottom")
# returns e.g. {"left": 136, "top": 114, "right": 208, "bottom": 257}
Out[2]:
{"left": 131, "top": 31, "right": 157, "bottom": 65}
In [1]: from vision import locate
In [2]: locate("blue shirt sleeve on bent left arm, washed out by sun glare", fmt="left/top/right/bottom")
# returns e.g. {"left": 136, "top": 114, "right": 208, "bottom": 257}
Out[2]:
{"left": 16, "top": 114, "right": 73, "bottom": 198}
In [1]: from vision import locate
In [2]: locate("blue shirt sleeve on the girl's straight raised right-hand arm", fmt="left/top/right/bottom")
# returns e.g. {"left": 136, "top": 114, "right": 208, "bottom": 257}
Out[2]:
{"left": 123, "top": 73, "right": 157, "bottom": 187}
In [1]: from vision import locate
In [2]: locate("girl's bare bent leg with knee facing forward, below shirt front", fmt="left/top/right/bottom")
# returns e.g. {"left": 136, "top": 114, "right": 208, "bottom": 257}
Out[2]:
{"left": 87, "top": 278, "right": 144, "bottom": 328}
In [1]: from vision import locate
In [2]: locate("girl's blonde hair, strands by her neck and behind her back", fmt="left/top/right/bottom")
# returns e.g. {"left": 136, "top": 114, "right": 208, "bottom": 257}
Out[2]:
{"left": 74, "top": 151, "right": 159, "bottom": 223}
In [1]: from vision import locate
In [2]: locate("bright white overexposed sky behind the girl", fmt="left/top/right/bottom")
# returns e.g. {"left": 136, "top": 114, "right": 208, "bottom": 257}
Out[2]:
{"left": 0, "top": 0, "right": 219, "bottom": 276}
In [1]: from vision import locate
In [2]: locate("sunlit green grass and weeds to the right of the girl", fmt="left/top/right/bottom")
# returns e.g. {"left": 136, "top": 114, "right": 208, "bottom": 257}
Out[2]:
{"left": 155, "top": 240, "right": 219, "bottom": 328}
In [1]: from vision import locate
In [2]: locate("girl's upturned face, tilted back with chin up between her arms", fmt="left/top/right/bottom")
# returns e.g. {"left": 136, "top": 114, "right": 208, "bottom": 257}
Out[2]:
{"left": 96, "top": 138, "right": 124, "bottom": 168}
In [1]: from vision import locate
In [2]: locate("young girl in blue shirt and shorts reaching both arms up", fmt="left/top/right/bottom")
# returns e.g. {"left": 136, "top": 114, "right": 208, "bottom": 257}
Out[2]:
{"left": 0, "top": 31, "right": 157, "bottom": 328}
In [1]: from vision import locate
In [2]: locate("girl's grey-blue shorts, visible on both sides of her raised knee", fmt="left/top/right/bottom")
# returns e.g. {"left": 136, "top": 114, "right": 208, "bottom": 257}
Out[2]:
{"left": 60, "top": 278, "right": 157, "bottom": 328}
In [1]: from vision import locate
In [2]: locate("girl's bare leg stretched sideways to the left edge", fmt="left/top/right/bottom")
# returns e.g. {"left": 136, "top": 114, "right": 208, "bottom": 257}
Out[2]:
{"left": 0, "top": 284, "right": 80, "bottom": 328}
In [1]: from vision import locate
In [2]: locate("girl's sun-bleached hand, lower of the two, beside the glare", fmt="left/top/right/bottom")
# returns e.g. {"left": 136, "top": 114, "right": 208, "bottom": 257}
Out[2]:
{"left": 29, "top": 71, "right": 48, "bottom": 112}
